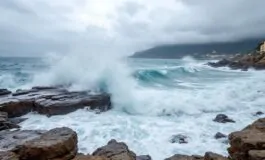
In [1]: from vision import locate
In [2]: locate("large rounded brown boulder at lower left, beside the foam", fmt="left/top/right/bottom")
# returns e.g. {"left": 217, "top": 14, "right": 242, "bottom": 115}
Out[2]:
{"left": 13, "top": 127, "right": 77, "bottom": 160}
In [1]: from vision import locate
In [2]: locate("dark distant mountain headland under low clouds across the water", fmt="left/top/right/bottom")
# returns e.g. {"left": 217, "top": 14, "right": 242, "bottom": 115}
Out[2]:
{"left": 131, "top": 38, "right": 264, "bottom": 58}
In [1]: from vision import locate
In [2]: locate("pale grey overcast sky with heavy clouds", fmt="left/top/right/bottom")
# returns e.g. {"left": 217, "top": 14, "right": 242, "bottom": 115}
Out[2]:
{"left": 0, "top": 0, "right": 265, "bottom": 56}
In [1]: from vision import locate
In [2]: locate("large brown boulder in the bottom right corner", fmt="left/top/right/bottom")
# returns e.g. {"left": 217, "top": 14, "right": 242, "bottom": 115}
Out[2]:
{"left": 228, "top": 118, "right": 265, "bottom": 160}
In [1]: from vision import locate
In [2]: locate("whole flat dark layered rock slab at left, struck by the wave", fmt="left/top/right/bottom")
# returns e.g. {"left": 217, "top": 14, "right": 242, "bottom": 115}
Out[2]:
{"left": 0, "top": 87, "right": 111, "bottom": 118}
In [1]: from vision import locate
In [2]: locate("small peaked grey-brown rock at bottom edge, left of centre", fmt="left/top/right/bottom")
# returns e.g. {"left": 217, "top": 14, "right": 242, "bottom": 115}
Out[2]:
{"left": 92, "top": 140, "right": 136, "bottom": 160}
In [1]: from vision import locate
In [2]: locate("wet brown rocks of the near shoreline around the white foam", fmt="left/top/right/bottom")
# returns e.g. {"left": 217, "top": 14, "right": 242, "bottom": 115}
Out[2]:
{"left": 0, "top": 87, "right": 265, "bottom": 160}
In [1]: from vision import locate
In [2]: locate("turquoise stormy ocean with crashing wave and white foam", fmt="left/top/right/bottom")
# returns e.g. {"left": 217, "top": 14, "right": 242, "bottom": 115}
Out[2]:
{"left": 0, "top": 57, "right": 265, "bottom": 160}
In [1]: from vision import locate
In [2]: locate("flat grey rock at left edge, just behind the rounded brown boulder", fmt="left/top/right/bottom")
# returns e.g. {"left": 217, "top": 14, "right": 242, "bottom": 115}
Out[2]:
{"left": 0, "top": 130, "right": 45, "bottom": 151}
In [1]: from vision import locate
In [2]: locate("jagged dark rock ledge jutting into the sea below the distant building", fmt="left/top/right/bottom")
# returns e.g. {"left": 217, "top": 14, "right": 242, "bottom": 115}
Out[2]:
{"left": 207, "top": 52, "right": 265, "bottom": 71}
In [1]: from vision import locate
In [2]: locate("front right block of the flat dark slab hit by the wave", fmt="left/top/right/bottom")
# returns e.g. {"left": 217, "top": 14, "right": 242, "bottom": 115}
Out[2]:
{"left": 35, "top": 92, "right": 111, "bottom": 116}
